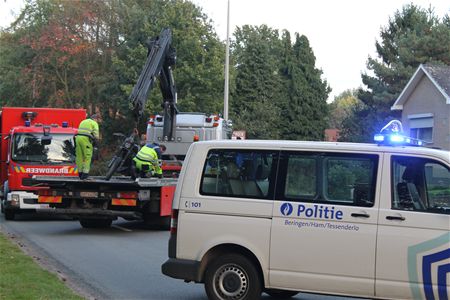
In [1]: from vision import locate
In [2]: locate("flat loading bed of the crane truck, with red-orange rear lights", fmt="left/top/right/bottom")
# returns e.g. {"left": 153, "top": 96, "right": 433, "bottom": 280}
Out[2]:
{"left": 31, "top": 176, "right": 178, "bottom": 220}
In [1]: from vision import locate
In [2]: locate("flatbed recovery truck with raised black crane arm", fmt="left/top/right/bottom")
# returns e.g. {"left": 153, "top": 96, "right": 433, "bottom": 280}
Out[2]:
{"left": 32, "top": 29, "right": 231, "bottom": 228}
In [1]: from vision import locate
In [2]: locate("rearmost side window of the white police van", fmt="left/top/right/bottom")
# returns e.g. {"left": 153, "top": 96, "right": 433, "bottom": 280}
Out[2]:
{"left": 200, "top": 149, "right": 277, "bottom": 199}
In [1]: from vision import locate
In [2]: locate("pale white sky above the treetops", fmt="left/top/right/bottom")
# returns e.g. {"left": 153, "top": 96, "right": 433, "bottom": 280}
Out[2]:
{"left": 0, "top": 0, "right": 450, "bottom": 101}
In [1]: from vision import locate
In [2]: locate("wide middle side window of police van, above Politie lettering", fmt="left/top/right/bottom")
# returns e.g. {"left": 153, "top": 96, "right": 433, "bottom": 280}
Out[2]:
{"left": 276, "top": 152, "right": 378, "bottom": 207}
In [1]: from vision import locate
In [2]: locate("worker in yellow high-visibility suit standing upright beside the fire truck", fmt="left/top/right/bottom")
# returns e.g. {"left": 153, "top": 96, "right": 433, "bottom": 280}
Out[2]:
{"left": 75, "top": 114, "right": 100, "bottom": 179}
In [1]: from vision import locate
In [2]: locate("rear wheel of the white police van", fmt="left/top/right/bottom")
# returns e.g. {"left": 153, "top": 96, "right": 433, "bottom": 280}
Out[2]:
{"left": 205, "top": 253, "right": 262, "bottom": 300}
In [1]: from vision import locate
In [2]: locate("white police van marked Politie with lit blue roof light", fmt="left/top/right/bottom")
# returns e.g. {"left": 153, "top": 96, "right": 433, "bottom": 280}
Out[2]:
{"left": 162, "top": 127, "right": 450, "bottom": 299}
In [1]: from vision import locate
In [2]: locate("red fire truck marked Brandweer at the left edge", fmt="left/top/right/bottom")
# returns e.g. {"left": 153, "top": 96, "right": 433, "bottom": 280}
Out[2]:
{"left": 0, "top": 107, "right": 86, "bottom": 220}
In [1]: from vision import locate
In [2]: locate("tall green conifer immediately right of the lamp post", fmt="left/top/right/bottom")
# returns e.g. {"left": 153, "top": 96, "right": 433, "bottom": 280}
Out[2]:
{"left": 230, "top": 25, "right": 281, "bottom": 139}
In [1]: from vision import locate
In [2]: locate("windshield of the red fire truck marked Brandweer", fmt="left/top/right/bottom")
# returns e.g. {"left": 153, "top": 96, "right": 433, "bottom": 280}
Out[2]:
{"left": 11, "top": 133, "right": 75, "bottom": 165}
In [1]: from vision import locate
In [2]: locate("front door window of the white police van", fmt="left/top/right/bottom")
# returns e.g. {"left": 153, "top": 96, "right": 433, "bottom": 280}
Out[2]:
{"left": 391, "top": 156, "right": 450, "bottom": 214}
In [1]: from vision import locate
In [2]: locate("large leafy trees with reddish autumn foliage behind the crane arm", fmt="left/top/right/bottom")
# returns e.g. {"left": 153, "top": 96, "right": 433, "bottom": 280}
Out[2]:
{"left": 0, "top": 0, "right": 224, "bottom": 142}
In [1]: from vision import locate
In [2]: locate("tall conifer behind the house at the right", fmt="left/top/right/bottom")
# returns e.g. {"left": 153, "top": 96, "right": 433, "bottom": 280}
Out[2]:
{"left": 341, "top": 4, "right": 450, "bottom": 142}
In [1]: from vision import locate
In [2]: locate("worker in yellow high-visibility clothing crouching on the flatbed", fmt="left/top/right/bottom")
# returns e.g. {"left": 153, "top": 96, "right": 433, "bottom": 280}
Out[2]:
{"left": 132, "top": 144, "right": 166, "bottom": 178}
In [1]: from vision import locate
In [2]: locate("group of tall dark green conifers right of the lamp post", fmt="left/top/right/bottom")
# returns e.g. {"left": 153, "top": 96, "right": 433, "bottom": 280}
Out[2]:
{"left": 231, "top": 25, "right": 329, "bottom": 140}
